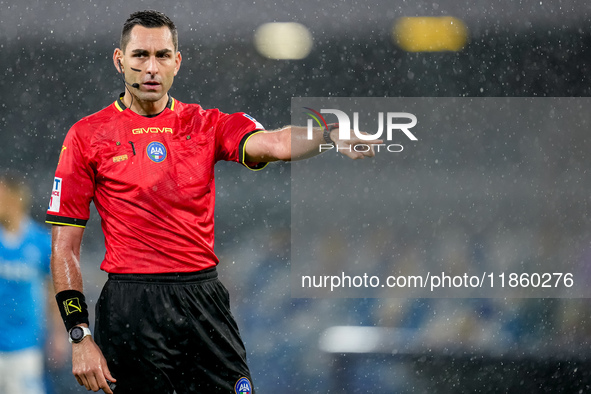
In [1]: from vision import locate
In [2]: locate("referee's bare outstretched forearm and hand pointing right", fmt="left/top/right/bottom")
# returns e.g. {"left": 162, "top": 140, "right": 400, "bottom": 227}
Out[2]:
{"left": 246, "top": 126, "right": 383, "bottom": 162}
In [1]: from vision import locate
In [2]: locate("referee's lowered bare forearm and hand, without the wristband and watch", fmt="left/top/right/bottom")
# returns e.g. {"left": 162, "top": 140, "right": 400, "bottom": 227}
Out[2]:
{"left": 51, "top": 225, "right": 115, "bottom": 394}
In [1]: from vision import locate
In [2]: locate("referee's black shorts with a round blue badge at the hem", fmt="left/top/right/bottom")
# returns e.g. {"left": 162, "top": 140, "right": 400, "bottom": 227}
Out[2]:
{"left": 95, "top": 268, "right": 252, "bottom": 394}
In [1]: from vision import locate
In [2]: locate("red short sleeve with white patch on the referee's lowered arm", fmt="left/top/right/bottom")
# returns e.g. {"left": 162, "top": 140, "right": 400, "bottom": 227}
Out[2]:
{"left": 46, "top": 125, "right": 95, "bottom": 227}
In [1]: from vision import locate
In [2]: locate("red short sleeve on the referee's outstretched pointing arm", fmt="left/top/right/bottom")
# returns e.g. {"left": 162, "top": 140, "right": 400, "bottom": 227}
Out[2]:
{"left": 215, "top": 112, "right": 267, "bottom": 170}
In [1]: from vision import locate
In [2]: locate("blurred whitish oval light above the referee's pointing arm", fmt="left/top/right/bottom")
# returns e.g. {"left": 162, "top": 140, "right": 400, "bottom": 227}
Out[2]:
{"left": 254, "top": 22, "right": 312, "bottom": 60}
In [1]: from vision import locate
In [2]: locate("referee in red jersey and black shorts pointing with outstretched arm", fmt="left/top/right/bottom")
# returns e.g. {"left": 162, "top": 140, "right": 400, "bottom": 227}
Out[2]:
{"left": 46, "top": 11, "right": 380, "bottom": 394}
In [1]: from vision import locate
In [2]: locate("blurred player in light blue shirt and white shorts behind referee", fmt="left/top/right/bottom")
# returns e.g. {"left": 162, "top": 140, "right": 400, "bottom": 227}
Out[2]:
{"left": 0, "top": 173, "right": 65, "bottom": 394}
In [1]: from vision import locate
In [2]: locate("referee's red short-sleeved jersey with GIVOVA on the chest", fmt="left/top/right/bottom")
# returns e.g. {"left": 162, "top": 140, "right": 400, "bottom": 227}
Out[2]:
{"left": 46, "top": 97, "right": 266, "bottom": 273}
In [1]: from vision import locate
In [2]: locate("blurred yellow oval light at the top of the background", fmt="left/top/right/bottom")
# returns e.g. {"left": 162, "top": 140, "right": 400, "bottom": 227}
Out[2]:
{"left": 392, "top": 16, "right": 468, "bottom": 52}
